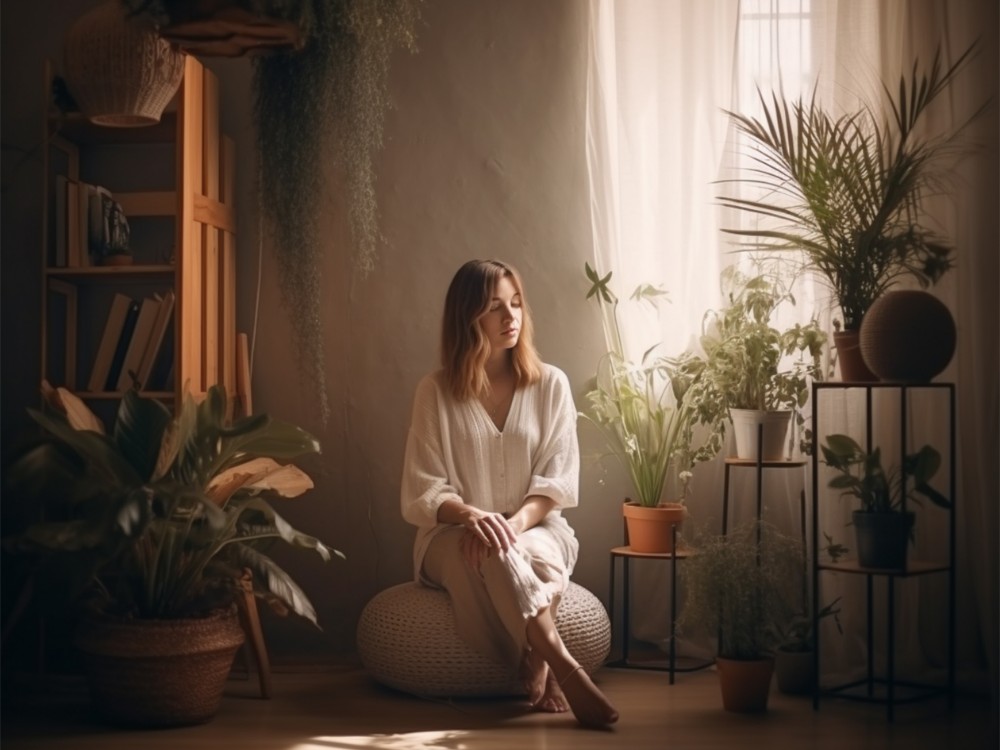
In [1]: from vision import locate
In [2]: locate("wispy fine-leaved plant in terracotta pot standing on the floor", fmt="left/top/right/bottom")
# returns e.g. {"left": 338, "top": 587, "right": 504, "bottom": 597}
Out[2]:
{"left": 678, "top": 521, "right": 803, "bottom": 712}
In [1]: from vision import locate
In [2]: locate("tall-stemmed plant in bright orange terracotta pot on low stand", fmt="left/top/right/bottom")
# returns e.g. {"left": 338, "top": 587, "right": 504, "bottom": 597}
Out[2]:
{"left": 580, "top": 264, "right": 722, "bottom": 552}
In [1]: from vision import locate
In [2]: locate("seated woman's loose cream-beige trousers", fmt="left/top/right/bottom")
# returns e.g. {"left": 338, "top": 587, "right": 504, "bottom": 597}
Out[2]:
{"left": 422, "top": 516, "right": 577, "bottom": 668}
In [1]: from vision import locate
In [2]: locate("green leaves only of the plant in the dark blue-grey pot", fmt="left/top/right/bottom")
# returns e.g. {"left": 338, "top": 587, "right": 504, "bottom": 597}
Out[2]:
{"left": 820, "top": 434, "right": 951, "bottom": 513}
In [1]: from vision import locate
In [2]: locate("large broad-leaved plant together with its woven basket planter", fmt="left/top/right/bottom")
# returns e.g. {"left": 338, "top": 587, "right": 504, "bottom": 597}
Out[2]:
{"left": 5, "top": 386, "right": 340, "bottom": 726}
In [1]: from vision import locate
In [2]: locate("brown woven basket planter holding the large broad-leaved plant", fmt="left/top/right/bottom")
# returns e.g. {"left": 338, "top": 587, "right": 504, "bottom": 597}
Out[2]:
{"left": 76, "top": 606, "right": 244, "bottom": 727}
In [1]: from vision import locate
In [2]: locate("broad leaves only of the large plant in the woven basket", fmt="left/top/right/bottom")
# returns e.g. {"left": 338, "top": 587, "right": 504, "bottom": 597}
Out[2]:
{"left": 6, "top": 386, "right": 342, "bottom": 624}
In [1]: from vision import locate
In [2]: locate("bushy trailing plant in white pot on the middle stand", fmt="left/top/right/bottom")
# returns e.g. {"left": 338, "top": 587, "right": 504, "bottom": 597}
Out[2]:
{"left": 672, "top": 266, "right": 826, "bottom": 461}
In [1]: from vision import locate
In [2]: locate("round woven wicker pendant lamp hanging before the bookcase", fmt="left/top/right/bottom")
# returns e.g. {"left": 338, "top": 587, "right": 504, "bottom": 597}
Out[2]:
{"left": 63, "top": 0, "right": 184, "bottom": 127}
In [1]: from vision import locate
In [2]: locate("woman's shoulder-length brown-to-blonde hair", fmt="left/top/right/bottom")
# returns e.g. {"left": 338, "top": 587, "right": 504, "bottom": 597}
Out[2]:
{"left": 441, "top": 260, "right": 542, "bottom": 401}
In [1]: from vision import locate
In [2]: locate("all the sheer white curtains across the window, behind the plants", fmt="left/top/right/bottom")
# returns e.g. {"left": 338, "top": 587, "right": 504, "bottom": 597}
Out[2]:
{"left": 587, "top": 0, "right": 1000, "bottom": 683}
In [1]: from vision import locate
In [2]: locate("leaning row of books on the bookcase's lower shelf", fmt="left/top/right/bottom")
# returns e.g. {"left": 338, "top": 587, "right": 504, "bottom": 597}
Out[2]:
{"left": 87, "top": 289, "right": 175, "bottom": 393}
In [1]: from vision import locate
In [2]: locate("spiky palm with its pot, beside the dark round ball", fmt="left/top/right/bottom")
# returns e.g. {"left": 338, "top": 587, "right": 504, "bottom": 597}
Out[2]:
{"left": 720, "top": 48, "right": 972, "bottom": 380}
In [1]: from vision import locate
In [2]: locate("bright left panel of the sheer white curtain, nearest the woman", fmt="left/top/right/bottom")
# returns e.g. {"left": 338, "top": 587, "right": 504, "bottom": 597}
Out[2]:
{"left": 587, "top": 0, "right": 739, "bottom": 364}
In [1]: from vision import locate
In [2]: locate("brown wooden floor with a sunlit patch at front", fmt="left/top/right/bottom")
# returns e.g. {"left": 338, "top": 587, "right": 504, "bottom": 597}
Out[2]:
{"left": 2, "top": 668, "right": 996, "bottom": 750}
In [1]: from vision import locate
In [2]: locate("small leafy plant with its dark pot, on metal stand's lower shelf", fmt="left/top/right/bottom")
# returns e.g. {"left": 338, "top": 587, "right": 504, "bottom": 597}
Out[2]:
{"left": 821, "top": 434, "right": 951, "bottom": 569}
